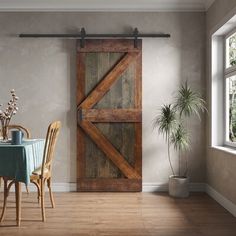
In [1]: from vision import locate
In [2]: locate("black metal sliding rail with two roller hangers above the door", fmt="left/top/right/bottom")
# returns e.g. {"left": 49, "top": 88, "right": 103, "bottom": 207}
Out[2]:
{"left": 19, "top": 28, "right": 170, "bottom": 48}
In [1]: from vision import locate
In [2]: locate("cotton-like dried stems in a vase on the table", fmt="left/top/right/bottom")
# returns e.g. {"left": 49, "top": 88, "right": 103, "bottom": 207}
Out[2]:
{"left": 0, "top": 89, "right": 19, "bottom": 141}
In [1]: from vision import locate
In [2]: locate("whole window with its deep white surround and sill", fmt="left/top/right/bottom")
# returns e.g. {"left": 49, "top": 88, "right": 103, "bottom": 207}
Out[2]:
{"left": 209, "top": 15, "right": 236, "bottom": 151}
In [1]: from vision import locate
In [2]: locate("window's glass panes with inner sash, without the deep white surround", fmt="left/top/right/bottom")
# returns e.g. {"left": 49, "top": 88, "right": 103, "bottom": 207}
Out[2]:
{"left": 224, "top": 31, "right": 236, "bottom": 147}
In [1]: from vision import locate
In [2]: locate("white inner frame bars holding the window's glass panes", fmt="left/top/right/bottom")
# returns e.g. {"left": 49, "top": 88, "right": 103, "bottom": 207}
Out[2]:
{"left": 223, "top": 28, "right": 236, "bottom": 148}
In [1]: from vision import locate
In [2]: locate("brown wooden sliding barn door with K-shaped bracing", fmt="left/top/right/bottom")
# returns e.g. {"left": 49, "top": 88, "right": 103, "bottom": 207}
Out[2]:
{"left": 77, "top": 39, "right": 142, "bottom": 191}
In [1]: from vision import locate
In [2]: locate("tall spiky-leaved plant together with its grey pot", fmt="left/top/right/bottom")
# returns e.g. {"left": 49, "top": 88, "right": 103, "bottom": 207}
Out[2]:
{"left": 154, "top": 82, "right": 206, "bottom": 197}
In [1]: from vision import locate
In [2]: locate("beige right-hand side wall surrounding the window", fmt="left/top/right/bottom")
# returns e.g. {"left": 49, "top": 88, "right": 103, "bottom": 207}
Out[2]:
{"left": 206, "top": 0, "right": 236, "bottom": 204}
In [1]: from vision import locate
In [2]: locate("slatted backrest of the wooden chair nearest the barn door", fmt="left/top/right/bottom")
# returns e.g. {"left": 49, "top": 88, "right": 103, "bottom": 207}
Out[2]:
{"left": 41, "top": 121, "right": 61, "bottom": 176}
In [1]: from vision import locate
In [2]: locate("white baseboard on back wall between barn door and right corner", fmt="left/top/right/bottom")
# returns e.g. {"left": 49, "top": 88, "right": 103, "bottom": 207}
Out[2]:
{"left": 143, "top": 183, "right": 206, "bottom": 192}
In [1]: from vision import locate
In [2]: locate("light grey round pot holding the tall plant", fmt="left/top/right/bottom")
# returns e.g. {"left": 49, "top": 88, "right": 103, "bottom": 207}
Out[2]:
{"left": 169, "top": 175, "right": 189, "bottom": 198}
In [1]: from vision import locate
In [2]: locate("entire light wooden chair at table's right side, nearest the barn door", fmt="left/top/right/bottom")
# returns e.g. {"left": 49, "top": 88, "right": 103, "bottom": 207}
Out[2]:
{"left": 30, "top": 121, "right": 61, "bottom": 221}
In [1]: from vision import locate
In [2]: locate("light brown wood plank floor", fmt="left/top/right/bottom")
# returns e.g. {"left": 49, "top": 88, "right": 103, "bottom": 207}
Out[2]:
{"left": 0, "top": 193, "right": 236, "bottom": 236}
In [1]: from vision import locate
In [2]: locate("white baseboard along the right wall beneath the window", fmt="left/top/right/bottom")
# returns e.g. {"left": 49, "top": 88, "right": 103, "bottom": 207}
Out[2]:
{"left": 206, "top": 184, "right": 236, "bottom": 217}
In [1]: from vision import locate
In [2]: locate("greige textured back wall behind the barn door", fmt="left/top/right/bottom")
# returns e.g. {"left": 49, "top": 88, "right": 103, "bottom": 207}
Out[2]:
{"left": 0, "top": 13, "right": 205, "bottom": 183}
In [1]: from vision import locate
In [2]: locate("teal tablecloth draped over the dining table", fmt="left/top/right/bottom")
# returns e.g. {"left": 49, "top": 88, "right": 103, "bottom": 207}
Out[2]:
{"left": 0, "top": 139, "right": 45, "bottom": 184}
